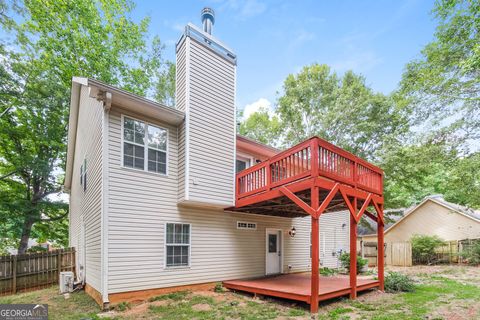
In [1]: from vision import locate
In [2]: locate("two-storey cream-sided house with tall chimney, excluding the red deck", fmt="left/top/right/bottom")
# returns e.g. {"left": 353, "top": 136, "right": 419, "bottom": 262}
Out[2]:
{"left": 65, "top": 16, "right": 349, "bottom": 305}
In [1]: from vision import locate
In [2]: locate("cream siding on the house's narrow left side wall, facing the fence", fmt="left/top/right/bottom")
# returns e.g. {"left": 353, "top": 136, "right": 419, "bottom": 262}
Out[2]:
{"left": 69, "top": 87, "right": 103, "bottom": 292}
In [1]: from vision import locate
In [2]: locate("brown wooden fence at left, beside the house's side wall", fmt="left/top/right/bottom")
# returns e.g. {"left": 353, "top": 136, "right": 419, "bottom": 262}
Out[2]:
{"left": 0, "top": 248, "right": 75, "bottom": 295}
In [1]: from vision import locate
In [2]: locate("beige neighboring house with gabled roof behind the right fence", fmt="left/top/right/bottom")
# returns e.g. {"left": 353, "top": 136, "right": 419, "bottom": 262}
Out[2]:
{"left": 362, "top": 195, "right": 480, "bottom": 243}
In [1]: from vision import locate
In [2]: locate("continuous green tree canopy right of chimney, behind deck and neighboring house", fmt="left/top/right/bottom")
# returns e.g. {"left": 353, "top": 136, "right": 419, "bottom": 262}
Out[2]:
{"left": 241, "top": 0, "right": 480, "bottom": 208}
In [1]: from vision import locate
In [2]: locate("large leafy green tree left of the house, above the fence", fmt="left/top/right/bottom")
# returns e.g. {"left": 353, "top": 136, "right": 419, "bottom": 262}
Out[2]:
{"left": 0, "top": 0, "right": 172, "bottom": 253}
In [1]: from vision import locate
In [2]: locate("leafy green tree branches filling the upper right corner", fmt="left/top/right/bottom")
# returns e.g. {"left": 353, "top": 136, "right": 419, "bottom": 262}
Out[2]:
{"left": 401, "top": 0, "right": 480, "bottom": 146}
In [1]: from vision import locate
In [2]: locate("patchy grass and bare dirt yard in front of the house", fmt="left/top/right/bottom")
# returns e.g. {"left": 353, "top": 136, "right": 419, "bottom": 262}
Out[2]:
{"left": 0, "top": 268, "right": 480, "bottom": 320}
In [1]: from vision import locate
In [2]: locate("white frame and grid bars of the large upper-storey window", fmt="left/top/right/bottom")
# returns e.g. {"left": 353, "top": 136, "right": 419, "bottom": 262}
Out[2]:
{"left": 120, "top": 114, "right": 170, "bottom": 177}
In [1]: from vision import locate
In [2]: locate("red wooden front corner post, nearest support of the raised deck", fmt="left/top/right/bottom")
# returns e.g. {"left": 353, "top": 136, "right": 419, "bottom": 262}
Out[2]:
{"left": 310, "top": 187, "right": 320, "bottom": 314}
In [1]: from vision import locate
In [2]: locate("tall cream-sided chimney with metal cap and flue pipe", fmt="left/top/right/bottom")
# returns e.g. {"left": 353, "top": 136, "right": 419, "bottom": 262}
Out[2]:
{"left": 175, "top": 8, "right": 237, "bottom": 208}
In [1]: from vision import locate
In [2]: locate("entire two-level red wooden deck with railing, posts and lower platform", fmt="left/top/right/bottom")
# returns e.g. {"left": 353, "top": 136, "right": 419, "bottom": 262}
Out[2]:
{"left": 225, "top": 137, "right": 384, "bottom": 313}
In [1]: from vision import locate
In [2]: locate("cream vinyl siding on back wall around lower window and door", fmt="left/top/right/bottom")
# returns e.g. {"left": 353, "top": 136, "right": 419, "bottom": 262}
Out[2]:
{"left": 108, "top": 107, "right": 322, "bottom": 293}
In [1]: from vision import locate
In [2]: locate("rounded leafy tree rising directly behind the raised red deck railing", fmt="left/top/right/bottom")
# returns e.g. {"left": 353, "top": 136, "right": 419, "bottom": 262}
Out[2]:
{"left": 276, "top": 64, "right": 408, "bottom": 159}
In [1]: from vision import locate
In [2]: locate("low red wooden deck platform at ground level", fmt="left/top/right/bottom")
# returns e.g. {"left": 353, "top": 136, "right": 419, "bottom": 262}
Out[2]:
{"left": 223, "top": 273, "right": 379, "bottom": 303}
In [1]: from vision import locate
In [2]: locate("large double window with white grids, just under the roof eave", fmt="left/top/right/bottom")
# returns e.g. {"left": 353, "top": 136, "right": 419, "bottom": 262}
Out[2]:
{"left": 123, "top": 117, "right": 168, "bottom": 174}
